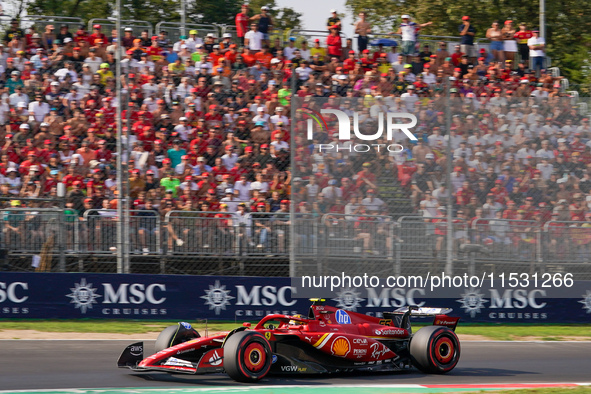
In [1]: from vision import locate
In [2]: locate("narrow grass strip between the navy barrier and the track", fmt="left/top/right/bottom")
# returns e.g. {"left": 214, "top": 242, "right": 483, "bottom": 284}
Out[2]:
{"left": 0, "top": 319, "right": 591, "bottom": 341}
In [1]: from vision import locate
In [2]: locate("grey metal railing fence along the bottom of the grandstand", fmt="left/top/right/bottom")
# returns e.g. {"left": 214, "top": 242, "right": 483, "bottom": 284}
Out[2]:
{"left": 0, "top": 208, "right": 591, "bottom": 278}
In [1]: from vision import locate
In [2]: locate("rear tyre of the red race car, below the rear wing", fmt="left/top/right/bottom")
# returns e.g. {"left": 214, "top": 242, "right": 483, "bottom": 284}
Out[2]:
{"left": 410, "top": 326, "right": 460, "bottom": 373}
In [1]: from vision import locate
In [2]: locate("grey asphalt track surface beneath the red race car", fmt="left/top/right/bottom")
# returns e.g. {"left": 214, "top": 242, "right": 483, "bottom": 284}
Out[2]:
{"left": 0, "top": 340, "right": 591, "bottom": 390}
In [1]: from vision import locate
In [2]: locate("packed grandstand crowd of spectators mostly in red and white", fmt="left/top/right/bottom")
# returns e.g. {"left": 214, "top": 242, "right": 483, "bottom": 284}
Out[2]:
{"left": 0, "top": 7, "right": 591, "bottom": 270}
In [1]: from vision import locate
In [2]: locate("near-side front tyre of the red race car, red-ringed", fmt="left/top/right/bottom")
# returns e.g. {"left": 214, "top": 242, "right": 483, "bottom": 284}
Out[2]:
{"left": 224, "top": 331, "right": 273, "bottom": 383}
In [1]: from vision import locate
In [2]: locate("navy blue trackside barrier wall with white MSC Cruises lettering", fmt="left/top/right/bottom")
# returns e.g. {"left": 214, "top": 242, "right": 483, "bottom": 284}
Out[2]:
{"left": 0, "top": 273, "right": 591, "bottom": 326}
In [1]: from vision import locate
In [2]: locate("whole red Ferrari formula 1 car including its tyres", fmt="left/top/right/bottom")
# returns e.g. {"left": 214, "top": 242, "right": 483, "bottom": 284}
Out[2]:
{"left": 117, "top": 300, "right": 460, "bottom": 382}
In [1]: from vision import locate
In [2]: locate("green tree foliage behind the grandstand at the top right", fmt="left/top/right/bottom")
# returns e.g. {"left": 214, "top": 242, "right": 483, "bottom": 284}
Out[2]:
{"left": 347, "top": 0, "right": 591, "bottom": 83}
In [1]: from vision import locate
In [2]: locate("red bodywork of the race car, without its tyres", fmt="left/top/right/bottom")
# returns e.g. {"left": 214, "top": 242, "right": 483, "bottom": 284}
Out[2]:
{"left": 127, "top": 305, "right": 459, "bottom": 374}
